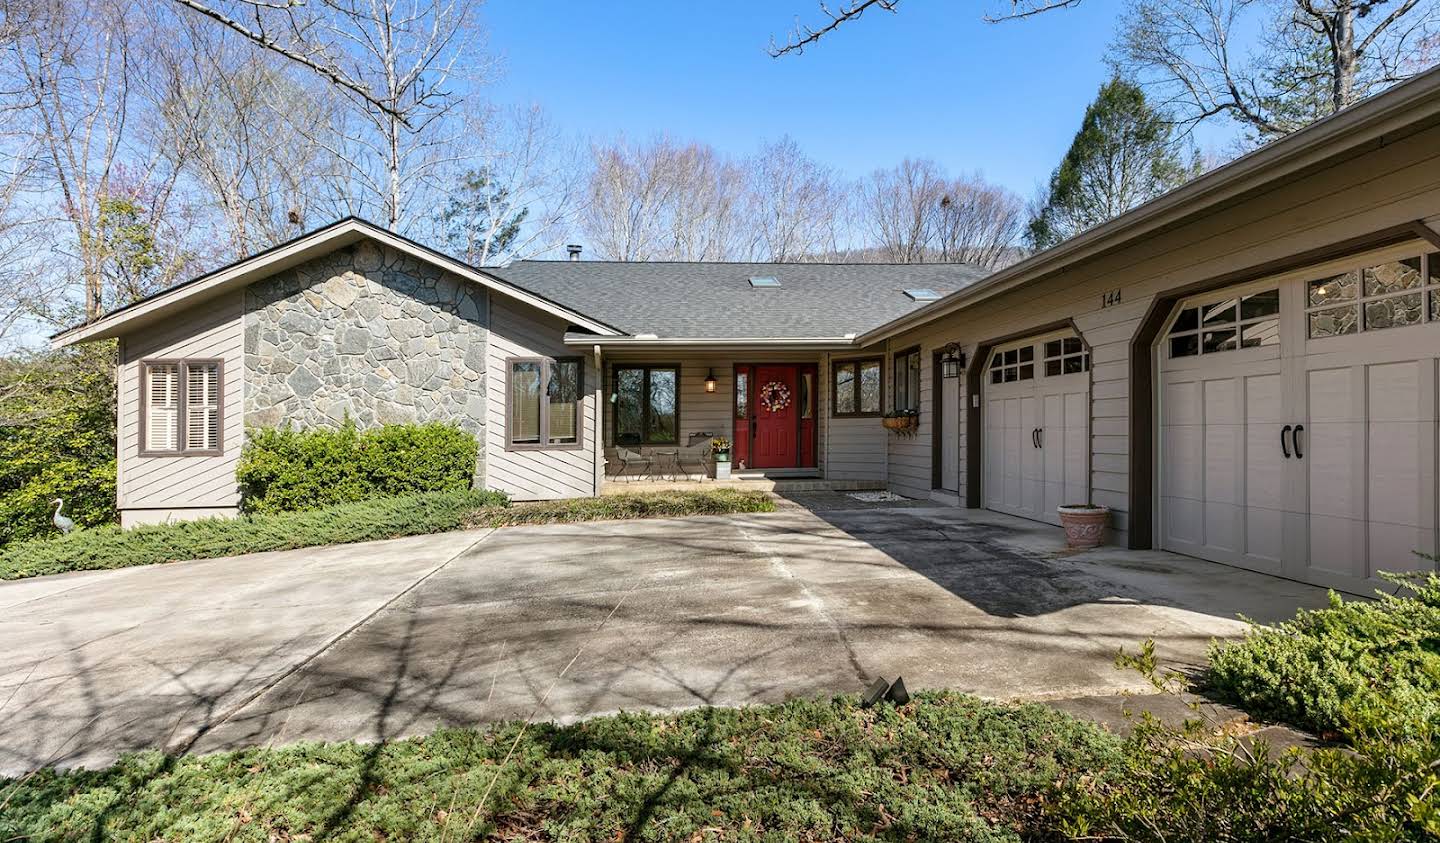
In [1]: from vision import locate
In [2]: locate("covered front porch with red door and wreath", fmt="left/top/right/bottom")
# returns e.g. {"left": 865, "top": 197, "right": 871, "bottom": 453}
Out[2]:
{"left": 581, "top": 341, "right": 887, "bottom": 491}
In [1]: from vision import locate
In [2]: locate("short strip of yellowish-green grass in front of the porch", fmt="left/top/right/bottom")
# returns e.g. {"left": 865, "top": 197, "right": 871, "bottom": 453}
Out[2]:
{"left": 469, "top": 489, "right": 775, "bottom": 527}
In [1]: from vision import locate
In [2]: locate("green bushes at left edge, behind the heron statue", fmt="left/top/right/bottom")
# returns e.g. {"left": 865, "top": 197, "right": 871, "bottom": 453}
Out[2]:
{"left": 0, "top": 343, "right": 115, "bottom": 548}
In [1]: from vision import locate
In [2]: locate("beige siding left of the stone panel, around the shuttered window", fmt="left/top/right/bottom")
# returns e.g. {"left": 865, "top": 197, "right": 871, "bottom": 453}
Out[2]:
{"left": 117, "top": 291, "right": 245, "bottom": 512}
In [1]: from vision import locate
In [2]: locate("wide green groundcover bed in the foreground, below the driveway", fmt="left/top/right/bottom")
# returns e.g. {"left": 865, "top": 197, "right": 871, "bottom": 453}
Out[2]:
{"left": 0, "top": 693, "right": 1116, "bottom": 842}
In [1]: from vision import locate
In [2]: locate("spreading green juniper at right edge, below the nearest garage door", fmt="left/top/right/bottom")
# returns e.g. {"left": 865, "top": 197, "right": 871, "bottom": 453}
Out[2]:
{"left": 1208, "top": 574, "right": 1440, "bottom": 733}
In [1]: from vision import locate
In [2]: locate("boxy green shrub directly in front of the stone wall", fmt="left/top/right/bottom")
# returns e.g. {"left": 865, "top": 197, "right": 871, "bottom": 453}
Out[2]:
{"left": 235, "top": 419, "right": 480, "bottom": 513}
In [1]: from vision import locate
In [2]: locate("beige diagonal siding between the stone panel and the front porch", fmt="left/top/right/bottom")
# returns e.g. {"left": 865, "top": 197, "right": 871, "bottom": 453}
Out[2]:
{"left": 485, "top": 295, "right": 599, "bottom": 500}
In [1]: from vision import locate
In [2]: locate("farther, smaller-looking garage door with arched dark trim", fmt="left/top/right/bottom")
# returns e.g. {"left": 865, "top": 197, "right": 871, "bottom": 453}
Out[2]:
{"left": 982, "top": 334, "right": 1090, "bottom": 525}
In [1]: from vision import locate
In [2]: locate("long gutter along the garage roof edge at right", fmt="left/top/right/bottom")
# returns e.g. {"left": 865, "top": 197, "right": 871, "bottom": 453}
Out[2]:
{"left": 857, "top": 61, "right": 1440, "bottom": 344}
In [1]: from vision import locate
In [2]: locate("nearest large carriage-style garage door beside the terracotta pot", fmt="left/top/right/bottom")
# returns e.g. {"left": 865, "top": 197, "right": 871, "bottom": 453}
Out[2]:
{"left": 1158, "top": 245, "right": 1440, "bottom": 594}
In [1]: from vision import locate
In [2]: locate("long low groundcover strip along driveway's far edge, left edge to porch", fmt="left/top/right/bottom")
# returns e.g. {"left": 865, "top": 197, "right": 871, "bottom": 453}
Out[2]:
{"left": 0, "top": 489, "right": 775, "bottom": 579}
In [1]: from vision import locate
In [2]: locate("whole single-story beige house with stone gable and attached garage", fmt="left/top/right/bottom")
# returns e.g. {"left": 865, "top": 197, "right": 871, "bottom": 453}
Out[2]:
{"left": 53, "top": 64, "right": 1440, "bottom": 591}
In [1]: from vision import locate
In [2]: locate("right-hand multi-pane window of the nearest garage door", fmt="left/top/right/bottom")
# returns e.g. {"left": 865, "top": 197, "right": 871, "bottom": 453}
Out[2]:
{"left": 1305, "top": 255, "right": 1440, "bottom": 339}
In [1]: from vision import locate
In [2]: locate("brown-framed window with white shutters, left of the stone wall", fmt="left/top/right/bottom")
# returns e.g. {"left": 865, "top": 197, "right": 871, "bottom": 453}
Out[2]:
{"left": 140, "top": 360, "right": 225, "bottom": 455}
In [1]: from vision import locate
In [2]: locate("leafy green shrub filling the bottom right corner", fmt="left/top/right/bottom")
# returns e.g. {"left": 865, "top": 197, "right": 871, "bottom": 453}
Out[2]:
{"left": 1047, "top": 722, "right": 1440, "bottom": 843}
